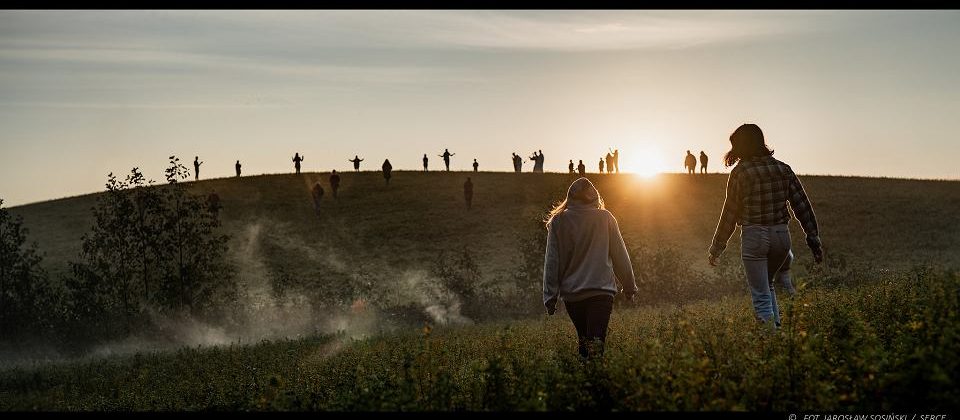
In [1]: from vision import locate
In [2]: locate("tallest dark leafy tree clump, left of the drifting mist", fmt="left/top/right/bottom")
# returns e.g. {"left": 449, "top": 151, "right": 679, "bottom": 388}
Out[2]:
{"left": 67, "top": 156, "right": 237, "bottom": 337}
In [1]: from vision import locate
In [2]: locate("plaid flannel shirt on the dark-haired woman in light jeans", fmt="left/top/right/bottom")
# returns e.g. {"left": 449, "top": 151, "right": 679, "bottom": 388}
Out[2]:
{"left": 710, "top": 156, "right": 820, "bottom": 257}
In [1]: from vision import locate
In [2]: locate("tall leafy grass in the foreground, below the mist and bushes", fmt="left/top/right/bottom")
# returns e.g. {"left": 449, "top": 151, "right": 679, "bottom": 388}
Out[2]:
{"left": 0, "top": 269, "right": 960, "bottom": 412}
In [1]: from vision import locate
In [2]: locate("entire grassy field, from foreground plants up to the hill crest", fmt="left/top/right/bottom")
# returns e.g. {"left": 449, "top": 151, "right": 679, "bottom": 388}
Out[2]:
{"left": 0, "top": 171, "right": 960, "bottom": 411}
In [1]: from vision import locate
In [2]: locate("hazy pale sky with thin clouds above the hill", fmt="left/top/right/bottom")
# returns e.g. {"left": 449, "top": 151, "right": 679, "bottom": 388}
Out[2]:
{"left": 0, "top": 10, "right": 960, "bottom": 205}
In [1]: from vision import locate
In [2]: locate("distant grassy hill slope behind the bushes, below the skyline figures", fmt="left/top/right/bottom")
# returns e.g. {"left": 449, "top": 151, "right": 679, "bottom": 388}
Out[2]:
{"left": 10, "top": 171, "right": 960, "bottom": 282}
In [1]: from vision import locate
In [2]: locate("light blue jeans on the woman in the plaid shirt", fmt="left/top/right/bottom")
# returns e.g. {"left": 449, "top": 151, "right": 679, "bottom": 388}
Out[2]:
{"left": 740, "top": 224, "right": 793, "bottom": 327}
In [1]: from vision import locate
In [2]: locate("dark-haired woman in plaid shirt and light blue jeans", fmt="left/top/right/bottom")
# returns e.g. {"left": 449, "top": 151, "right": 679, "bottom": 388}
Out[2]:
{"left": 709, "top": 124, "right": 823, "bottom": 327}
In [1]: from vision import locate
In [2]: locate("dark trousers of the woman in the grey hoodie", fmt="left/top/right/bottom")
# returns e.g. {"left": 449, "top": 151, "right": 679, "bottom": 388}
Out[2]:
{"left": 564, "top": 295, "right": 613, "bottom": 358}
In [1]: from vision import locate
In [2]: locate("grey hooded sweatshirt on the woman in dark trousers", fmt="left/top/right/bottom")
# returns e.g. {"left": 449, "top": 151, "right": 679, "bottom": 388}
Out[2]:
{"left": 543, "top": 200, "right": 637, "bottom": 311}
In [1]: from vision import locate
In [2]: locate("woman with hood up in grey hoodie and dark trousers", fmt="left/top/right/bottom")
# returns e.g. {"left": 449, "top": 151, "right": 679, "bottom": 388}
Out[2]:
{"left": 543, "top": 178, "right": 637, "bottom": 358}
